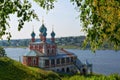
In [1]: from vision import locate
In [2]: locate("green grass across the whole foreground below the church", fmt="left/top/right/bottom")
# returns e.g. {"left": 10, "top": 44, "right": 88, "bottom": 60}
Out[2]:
{"left": 0, "top": 57, "right": 120, "bottom": 80}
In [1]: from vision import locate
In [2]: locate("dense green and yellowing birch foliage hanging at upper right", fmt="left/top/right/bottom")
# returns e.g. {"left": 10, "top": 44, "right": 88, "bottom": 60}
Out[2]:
{"left": 71, "top": 0, "right": 120, "bottom": 51}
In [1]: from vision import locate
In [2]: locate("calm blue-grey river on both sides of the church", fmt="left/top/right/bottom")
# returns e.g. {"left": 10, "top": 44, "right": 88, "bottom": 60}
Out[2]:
{"left": 5, "top": 48, "right": 120, "bottom": 75}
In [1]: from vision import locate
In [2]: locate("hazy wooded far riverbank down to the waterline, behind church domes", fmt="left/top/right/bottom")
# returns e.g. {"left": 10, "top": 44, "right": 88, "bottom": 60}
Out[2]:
{"left": 0, "top": 36, "right": 116, "bottom": 49}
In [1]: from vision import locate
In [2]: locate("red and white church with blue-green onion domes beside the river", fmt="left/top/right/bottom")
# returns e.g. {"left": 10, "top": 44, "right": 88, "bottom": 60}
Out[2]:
{"left": 23, "top": 20, "right": 92, "bottom": 72}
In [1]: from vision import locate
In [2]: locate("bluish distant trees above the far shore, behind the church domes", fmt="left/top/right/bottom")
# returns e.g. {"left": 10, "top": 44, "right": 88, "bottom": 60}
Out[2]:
{"left": 0, "top": 36, "right": 85, "bottom": 47}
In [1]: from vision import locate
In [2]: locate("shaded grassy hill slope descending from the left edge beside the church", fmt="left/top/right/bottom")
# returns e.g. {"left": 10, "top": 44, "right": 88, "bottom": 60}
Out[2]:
{"left": 0, "top": 57, "right": 60, "bottom": 80}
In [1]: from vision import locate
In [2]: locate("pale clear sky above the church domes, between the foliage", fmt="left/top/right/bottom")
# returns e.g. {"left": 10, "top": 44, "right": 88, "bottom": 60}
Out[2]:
{"left": 4, "top": 0, "right": 85, "bottom": 39}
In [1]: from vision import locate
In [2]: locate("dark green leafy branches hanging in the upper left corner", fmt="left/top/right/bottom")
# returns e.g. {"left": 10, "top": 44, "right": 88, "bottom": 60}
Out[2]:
{"left": 0, "top": 0, "right": 38, "bottom": 40}
